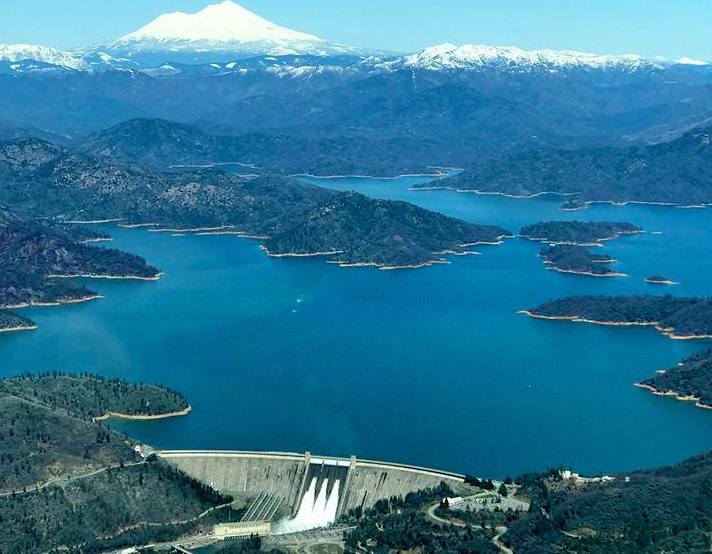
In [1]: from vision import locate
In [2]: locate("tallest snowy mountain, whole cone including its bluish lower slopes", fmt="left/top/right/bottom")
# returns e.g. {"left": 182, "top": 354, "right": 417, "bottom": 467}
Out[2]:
{"left": 104, "top": 0, "right": 357, "bottom": 61}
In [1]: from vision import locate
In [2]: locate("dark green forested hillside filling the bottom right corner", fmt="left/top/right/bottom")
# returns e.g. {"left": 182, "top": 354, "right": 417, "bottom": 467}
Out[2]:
{"left": 502, "top": 454, "right": 712, "bottom": 554}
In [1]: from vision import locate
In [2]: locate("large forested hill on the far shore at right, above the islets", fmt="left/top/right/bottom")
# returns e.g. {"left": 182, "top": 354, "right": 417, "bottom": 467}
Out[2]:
{"left": 415, "top": 127, "right": 712, "bottom": 209}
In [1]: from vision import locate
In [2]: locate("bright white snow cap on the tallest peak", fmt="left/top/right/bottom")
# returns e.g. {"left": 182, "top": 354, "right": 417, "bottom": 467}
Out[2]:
{"left": 119, "top": 0, "right": 322, "bottom": 44}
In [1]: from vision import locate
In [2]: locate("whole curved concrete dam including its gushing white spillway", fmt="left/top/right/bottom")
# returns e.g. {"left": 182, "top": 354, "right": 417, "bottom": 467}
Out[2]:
{"left": 157, "top": 451, "right": 464, "bottom": 532}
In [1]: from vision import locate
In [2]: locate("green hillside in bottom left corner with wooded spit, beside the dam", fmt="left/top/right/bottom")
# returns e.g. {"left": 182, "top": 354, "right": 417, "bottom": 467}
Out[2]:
{"left": 0, "top": 374, "right": 234, "bottom": 553}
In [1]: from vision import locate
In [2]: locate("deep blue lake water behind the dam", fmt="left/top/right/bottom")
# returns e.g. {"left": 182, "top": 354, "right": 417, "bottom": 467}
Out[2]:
{"left": 0, "top": 178, "right": 712, "bottom": 477}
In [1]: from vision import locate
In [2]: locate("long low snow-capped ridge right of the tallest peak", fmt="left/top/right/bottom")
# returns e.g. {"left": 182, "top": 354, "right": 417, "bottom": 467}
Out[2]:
{"left": 383, "top": 44, "right": 663, "bottom": 72}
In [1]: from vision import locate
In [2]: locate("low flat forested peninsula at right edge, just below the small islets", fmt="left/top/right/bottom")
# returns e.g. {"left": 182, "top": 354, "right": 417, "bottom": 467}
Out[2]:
{"left": 523, "top": 295, "right": 712, "bottom": 340}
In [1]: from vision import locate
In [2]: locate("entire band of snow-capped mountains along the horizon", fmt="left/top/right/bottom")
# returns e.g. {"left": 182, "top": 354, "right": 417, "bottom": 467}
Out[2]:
{"left": 0, "top": 0, "right": 712, "bottom": 79}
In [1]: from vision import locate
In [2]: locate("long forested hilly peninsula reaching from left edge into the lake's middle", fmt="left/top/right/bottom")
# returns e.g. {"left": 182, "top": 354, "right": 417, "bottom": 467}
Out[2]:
{"left": 0, "top": 139, "right": 510, "bottom": 267}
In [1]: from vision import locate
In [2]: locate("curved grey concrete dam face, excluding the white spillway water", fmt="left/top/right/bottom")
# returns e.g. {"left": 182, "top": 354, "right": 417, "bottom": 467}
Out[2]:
{"left": 156, "top": 451, "right": 464, "bottom": 517}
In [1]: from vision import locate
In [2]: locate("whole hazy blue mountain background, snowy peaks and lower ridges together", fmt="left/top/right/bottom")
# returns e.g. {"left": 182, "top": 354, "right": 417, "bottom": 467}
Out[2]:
{"left": 0, "top": 1, "right": 712, "bottom": 169}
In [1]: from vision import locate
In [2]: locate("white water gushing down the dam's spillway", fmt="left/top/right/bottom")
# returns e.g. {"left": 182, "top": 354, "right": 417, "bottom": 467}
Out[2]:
{"left": 274, "top": 477, "right": 341, "bottom": 535}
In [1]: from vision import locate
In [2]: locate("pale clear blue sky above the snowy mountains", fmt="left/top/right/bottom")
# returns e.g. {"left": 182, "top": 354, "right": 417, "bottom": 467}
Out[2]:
{"left": 0, "top": 0, "right": 712, "bottom": 60}
